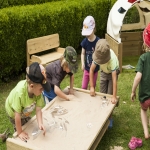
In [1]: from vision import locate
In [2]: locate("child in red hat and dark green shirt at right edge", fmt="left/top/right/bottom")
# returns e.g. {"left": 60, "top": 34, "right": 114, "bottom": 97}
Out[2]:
{"left": 131, "top": 24, "right": 150, "bottom": 139}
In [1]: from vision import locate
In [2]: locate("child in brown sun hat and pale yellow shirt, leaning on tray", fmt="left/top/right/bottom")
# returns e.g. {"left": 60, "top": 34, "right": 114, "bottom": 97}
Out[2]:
{"left": 90, "top": 39, "right": 120, "bottom": 128}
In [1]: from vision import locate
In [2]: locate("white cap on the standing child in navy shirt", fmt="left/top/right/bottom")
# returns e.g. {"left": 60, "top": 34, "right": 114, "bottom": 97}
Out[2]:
{"left": 82, "top": 16, "right": 95, "bottom": 36}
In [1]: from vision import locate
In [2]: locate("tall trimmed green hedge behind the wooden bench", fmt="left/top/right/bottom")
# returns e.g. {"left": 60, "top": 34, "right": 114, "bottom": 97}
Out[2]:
{"left": 0, "top": 0, "right": 110, "bottom": 81}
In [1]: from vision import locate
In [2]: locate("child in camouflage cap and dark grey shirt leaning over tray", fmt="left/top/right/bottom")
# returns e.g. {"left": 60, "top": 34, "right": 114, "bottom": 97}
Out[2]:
{"left": 43, "top": 46, "right": 78, "bottom": 101}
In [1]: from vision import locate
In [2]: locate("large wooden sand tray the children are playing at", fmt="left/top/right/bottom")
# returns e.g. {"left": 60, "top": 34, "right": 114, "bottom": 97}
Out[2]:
{"left": 7, "top": 87, "right": 119, "bottom": 150}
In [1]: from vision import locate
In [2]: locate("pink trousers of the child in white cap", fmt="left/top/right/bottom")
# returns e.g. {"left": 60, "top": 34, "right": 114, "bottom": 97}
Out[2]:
{"left": 82, "top": 70, "right": 98, "bottom": 89}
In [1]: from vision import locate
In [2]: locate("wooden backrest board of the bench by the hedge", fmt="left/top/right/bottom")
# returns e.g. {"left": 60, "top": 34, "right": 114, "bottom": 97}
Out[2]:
{"left": 27, "top": 34, "right": 60, "bottom": 54}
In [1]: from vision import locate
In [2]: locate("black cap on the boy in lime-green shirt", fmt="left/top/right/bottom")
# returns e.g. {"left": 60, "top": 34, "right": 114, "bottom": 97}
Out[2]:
{"left": 27, "top": 62, "right": 51, "bottom": 92}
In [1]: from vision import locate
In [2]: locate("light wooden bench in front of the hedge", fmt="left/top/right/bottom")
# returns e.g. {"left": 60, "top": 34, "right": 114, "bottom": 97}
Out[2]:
{"left": 27, "top": 34, "right": 65, "bottom": 66}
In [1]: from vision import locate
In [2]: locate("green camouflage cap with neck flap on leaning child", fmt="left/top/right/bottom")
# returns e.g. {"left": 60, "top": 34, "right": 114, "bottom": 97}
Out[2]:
{"left": 64, "top": 46, "right": 78, "bottom": 73}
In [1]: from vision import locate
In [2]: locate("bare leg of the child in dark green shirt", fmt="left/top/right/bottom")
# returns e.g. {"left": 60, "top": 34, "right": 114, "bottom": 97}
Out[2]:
{"left": 141, "top": 108, "right": 150, "bottom": 139}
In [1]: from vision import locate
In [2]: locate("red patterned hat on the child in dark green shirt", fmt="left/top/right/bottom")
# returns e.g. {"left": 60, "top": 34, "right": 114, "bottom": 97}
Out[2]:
{"left": 143, "top": 23, "right": 150, "bottom": 48}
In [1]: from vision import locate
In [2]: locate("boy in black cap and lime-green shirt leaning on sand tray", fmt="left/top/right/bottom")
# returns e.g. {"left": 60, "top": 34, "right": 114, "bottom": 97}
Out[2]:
{"left": 5, "top": 62, "right": 50, "bottom": 142}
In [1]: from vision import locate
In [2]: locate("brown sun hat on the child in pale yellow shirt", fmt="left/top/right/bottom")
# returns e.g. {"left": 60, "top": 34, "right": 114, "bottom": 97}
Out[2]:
{"left": 93, "top": 39, "right": 110, "bottom": 64}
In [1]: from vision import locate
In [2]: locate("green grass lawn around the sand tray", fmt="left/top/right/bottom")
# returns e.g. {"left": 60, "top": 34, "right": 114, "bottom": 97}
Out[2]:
{"left": 0, "top": 57, "right": 150, "bottom": 150}
